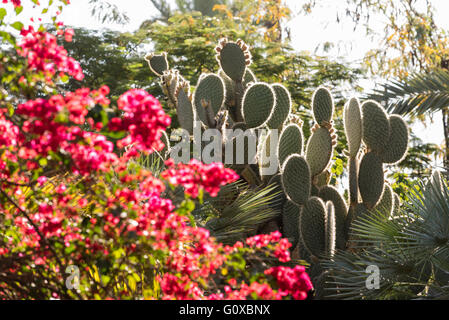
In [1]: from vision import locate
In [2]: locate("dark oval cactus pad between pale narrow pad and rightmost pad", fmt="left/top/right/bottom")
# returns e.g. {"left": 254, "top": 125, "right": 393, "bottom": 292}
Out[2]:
{"left": 362, "top": 100, "right": 390, "bottom": 152}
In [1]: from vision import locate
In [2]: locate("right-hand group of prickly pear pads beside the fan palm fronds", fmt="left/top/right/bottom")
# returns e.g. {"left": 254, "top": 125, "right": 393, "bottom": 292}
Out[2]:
{"left": 278, "top": 93, "right": 408, "bottom": 259}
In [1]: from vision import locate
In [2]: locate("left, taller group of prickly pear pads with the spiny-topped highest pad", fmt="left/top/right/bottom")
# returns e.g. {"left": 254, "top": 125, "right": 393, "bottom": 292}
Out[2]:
{"left": 146, "top": 39, "right": 292, "bottom": 179}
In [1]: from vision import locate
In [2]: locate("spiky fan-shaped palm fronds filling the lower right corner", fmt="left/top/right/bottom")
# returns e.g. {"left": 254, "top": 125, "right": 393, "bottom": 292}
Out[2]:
{"left": 324, "top": 174, "right": 449, "bottom": 299}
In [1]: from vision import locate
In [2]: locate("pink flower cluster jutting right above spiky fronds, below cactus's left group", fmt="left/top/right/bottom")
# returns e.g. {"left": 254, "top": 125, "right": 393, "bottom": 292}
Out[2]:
{"left": 161, "top": 159, "right": 239, "bottom": 198}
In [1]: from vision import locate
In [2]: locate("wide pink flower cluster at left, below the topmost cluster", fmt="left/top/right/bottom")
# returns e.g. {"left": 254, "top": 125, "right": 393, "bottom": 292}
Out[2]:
{"left": 16, "top": 87, "right": 118, "bottom": 175}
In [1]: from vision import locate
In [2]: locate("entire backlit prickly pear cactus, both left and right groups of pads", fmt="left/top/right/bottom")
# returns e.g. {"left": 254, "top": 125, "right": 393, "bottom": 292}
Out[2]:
{"left": 147, "top": 39, "right": 408, "bottom": 298}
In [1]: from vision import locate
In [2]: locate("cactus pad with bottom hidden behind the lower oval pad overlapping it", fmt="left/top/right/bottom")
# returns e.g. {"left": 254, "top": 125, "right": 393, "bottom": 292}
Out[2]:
{"left": 278, "top": 123, "right": 304, "bottom": 166}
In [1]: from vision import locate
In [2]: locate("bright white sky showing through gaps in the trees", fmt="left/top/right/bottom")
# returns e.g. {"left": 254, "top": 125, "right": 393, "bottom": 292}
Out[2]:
{"left": 0, "top": 0, "right": 449, "bottom": 155}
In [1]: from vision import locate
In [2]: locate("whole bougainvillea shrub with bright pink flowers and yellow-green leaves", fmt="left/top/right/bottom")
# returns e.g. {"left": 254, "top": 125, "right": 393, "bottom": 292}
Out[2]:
{"left": 0, "top": 0, "right": 312, "bottom": 299}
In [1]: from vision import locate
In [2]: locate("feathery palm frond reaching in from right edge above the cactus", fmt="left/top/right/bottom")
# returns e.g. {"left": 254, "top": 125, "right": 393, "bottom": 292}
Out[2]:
{"left": 368, "top": 69, "right": 449, "bottom": 115}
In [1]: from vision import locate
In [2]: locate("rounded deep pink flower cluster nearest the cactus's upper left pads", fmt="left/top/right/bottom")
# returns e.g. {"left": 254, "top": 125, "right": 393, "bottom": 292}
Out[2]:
{"left": 110, "top": 89, "right": 171, "bottom": 153}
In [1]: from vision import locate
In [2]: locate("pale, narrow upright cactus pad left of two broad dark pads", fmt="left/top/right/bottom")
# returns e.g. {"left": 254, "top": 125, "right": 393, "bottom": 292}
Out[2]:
{"left": 343, "top": 98, "right": 362, "bottom": 157}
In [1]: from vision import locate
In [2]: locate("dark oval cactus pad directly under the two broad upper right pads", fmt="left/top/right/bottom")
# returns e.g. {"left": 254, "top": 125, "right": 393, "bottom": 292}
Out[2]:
{"left": 359, "top": 152, "right": 384, "bottom": 209}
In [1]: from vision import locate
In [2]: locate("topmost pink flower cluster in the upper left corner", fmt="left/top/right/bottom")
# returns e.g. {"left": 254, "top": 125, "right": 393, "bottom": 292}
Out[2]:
{"left": 18, "top": 26, "right": 84, "bottom": 82}
